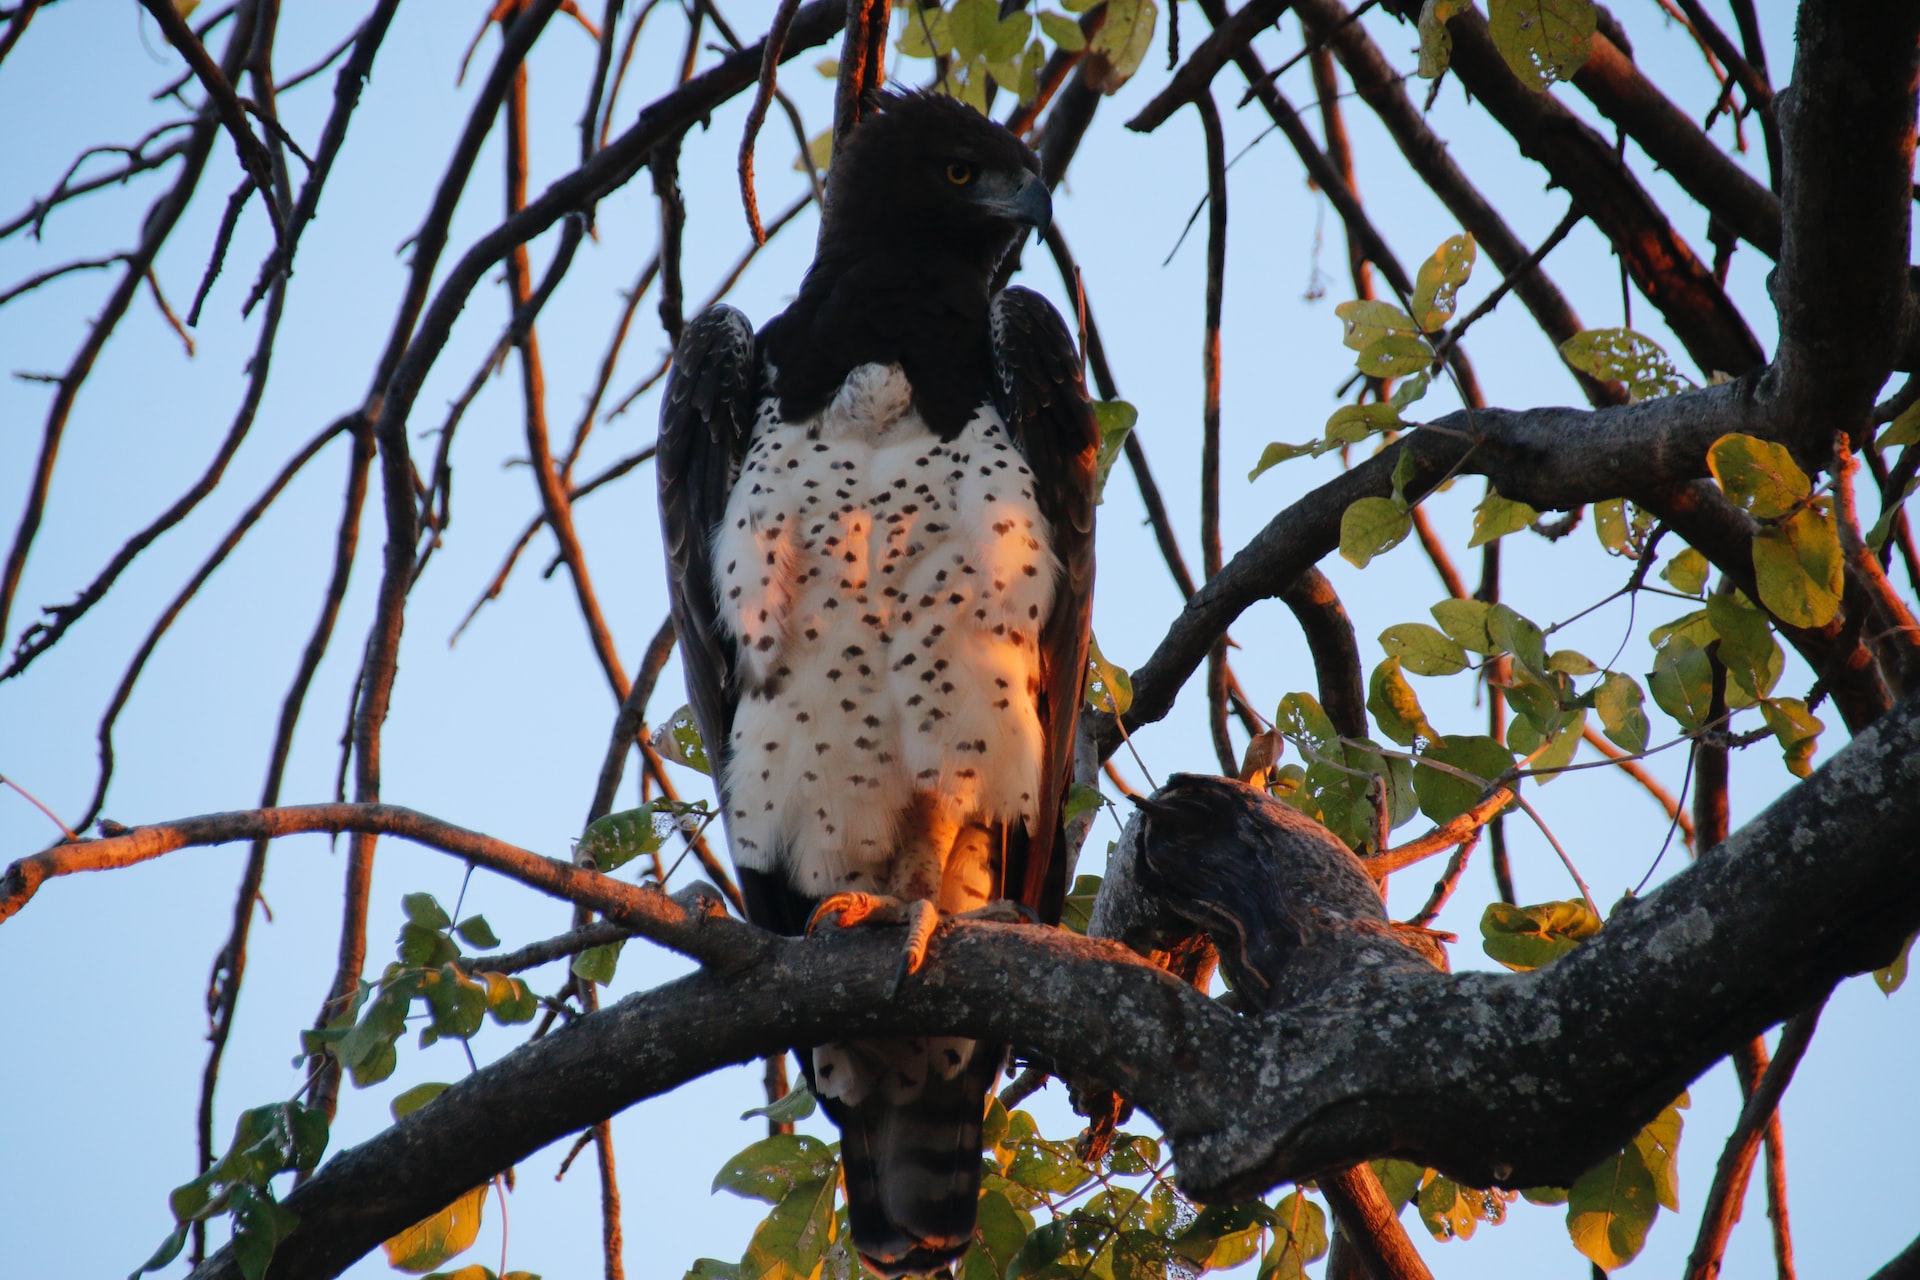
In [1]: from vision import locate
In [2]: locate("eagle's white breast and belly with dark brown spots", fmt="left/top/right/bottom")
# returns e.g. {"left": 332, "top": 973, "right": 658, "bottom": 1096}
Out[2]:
{"left": 714, "top": 365, "right": 1058, "bottom": 896}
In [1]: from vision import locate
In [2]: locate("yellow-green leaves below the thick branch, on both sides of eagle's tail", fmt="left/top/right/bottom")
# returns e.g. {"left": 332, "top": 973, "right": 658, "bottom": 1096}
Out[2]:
{"left": 685, "top": 1086, "right": 1327, "bottom": 1280}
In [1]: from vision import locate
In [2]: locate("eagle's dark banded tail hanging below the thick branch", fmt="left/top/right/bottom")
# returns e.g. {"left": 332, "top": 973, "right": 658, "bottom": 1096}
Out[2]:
{"left": 828, "top": 1044, "right": 1006, "bottom": 1280}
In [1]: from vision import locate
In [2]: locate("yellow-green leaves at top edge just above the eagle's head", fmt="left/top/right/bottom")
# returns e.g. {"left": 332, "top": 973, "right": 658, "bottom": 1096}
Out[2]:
{"left": 899, "top": 0, "right": 1160, "bottom": 111}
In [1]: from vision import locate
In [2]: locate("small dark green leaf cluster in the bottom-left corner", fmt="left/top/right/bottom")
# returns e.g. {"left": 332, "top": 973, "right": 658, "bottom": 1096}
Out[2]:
{"left": 132, "top": 1102, "right": 328, "bottom": 1280}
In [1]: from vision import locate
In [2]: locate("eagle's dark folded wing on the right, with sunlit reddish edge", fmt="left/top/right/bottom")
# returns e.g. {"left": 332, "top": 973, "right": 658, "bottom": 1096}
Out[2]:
{"left": 993, "top": 288, "right": 1100, "bottom": 923}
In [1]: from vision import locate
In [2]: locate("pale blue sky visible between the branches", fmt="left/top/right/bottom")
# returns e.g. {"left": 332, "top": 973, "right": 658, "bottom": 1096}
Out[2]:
{"left": 0, "top": 0, "right": 1920, "bottom": 1280}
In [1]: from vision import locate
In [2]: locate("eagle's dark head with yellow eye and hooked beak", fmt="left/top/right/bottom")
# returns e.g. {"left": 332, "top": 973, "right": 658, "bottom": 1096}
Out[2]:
{"left": 820, "top": 92, "right": 1052, "bottom": 276}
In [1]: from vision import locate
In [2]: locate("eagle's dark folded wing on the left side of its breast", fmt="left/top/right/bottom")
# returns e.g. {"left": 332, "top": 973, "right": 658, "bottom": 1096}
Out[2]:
{"left": 655, "top": 307, "right": 760, "bottom": 808}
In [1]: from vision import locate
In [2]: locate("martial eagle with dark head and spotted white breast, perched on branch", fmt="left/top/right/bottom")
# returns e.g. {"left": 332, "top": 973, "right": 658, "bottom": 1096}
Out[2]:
{"left": 659, "top": 94, "right": 1098, "bottom": 1276}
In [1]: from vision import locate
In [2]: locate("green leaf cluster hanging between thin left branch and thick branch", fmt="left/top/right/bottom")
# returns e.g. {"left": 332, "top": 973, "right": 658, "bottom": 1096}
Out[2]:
{"left": 301, "top": 894, "right": 540, "bottom": 1088}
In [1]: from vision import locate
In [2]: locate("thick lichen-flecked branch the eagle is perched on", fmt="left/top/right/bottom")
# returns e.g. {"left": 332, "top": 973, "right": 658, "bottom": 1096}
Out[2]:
{"left": 161, "top": 697, "right": 1920, "bottom": 1280}
